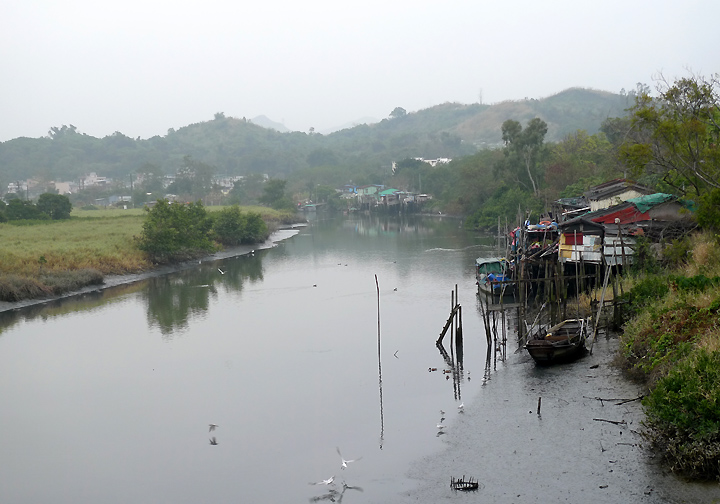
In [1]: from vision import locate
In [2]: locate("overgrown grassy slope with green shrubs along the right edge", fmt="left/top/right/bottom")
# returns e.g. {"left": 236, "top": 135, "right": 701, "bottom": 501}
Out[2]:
{"left": 619, "top": 234, "right": 720, "bottom": 479}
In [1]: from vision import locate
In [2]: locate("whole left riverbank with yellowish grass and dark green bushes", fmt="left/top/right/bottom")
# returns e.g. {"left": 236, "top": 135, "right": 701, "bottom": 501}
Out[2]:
{"left": 0, "top": 200, "right": 297, "bottom": 302}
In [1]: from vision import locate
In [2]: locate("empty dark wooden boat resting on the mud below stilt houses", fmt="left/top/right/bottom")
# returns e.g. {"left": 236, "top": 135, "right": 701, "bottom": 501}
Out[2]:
{"left": 525, "top": 319, "right": 587, "bottom": 365}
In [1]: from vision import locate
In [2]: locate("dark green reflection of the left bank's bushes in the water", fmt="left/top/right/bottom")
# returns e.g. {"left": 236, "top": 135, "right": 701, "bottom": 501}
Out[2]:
{"left": 143, "top": 253, "right": 263, "bottom": 339}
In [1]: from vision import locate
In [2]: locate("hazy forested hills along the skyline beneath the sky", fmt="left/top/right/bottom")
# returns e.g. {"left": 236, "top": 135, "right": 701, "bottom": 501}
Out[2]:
{"left": 0, "top": 89, "right": 628, "bottom": 192}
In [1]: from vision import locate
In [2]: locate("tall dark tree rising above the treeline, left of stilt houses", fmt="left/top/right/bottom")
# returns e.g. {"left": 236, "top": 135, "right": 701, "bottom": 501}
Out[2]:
{"left": 501, "top": 117, "right": 547, "bottom": 196}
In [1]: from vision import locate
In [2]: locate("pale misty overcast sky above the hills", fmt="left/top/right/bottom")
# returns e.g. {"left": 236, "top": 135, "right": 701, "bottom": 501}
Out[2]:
{"left": 0, "top": 0, "right": 720, "bottom": 141}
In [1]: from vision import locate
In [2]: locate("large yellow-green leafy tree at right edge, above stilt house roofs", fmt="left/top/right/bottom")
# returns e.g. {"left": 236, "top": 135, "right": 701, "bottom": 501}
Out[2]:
{"left": 620, "top": 74, "right": 720, "bottom": 196}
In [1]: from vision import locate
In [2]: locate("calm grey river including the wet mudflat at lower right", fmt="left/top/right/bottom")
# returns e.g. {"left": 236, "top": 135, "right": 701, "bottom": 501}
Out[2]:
{"left": 0, "top": 215, "right": 720, "bottom": 504}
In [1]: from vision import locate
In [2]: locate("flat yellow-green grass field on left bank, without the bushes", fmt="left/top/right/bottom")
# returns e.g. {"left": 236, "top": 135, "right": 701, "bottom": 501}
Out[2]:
{"left": 0, "top": 207, "right": 298, "bottom": 301}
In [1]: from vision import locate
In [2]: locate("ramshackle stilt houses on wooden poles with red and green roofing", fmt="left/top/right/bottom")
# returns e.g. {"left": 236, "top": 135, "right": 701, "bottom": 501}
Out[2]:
{"left": 476, "top": 179, "right": 695, "bottom": 359}
